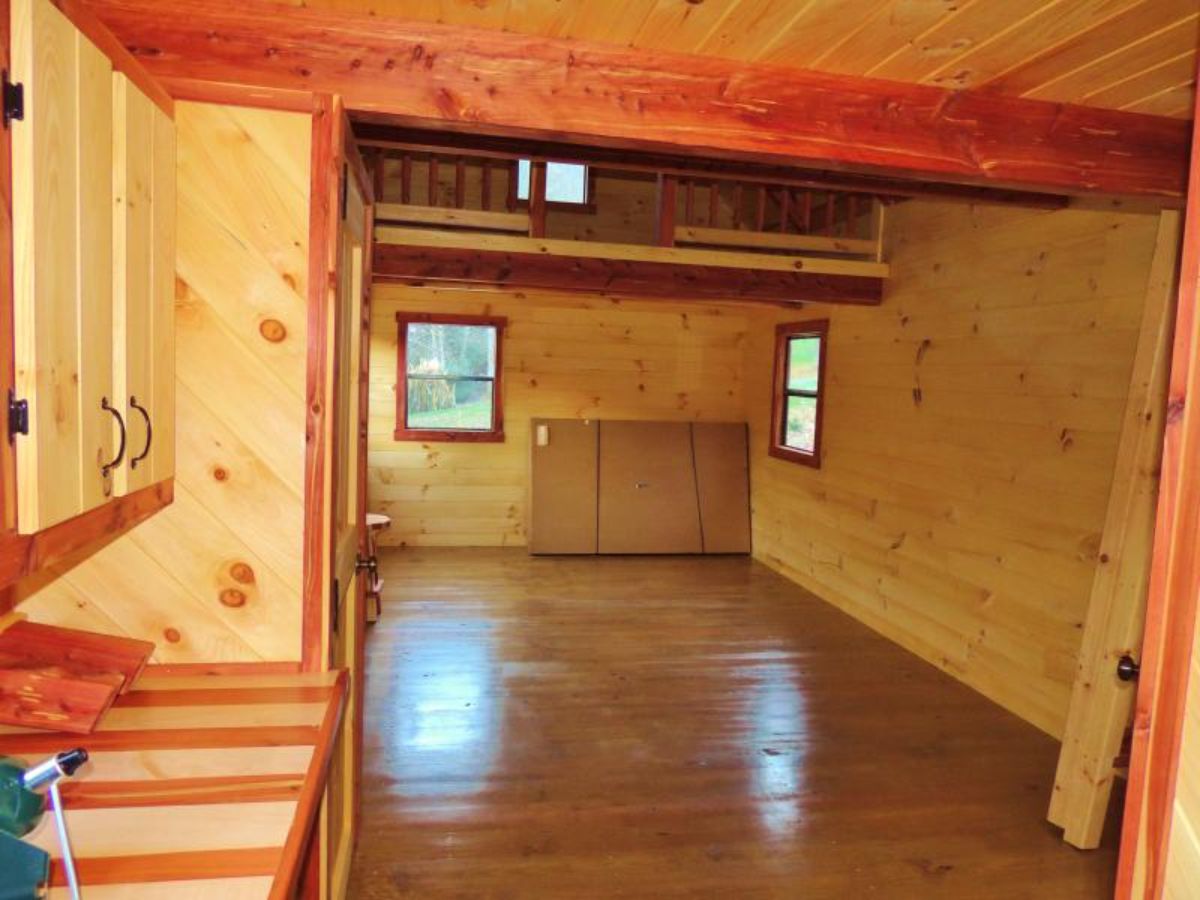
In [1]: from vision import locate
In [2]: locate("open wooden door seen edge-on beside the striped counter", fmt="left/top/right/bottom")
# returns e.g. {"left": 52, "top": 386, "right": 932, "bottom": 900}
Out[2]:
{"left": 326, "top": 125, "right": 373, "bottom": 898}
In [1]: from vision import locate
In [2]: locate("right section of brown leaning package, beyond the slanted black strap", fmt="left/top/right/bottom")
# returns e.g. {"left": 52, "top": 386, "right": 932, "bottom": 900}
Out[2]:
{"left": 691, "top": 422, "right": 750, "bottom": 553}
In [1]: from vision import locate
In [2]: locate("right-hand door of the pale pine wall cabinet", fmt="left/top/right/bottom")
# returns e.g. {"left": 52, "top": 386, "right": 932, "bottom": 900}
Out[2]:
{"left": 112, "top": 72, "right": 175, "bottom": 496}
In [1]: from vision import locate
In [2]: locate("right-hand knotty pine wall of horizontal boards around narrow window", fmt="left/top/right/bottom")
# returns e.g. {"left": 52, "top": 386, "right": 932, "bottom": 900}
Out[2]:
{"left": 745, "top": 202, "right": 1157, "bottom": 737}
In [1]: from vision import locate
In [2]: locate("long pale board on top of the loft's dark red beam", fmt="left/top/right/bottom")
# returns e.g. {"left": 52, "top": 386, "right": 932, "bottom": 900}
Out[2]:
{"left": 376, "top": 226, "right": 889, "bottom": 278}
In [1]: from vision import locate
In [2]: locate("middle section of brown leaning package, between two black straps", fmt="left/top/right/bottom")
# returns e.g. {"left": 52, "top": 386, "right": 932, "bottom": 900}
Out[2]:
{"left": 599, "top": 422, "right": 703, "bottom": 553}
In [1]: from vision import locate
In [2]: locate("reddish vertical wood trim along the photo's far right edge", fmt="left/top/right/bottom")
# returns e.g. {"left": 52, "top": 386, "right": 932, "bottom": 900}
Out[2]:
{"left": 1116, "top": 63, "right": 1200, "bottom": 900}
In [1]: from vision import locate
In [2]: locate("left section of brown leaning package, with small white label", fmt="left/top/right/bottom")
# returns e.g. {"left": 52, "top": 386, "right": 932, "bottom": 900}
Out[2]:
{"left": 529, "top": 419, "right": 600, "bottom": 553}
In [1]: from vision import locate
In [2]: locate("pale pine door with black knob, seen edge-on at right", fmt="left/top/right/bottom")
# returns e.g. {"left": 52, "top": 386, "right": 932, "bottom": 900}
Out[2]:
{"left": 1048, "top": 210, "right": 1182, "bottom": 850}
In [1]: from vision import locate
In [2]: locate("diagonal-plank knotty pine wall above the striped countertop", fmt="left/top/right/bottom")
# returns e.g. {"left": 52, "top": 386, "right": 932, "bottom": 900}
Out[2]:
{"left": 19, "top": 103, "right": 311, "bottom": 662}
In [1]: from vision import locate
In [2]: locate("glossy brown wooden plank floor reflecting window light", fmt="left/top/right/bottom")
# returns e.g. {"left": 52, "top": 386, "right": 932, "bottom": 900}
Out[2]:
{"left": 350, "top": 550, "right": 1115, "bottom": 900}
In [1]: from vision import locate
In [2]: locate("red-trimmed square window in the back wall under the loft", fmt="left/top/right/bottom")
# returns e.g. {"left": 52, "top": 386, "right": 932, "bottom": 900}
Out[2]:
{"left": 395, "top": 313, "right": 506, "bottom": 442}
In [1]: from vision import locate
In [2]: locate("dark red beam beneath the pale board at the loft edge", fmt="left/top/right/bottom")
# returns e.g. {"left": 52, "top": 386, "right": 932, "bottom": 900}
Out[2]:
{"left": 373, "top": 244, "right": 883, "bottom": 306}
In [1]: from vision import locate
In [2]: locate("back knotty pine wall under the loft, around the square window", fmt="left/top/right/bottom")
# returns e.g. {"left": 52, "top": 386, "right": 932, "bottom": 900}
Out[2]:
{"left": 367, "top": 284, "right": 748, "bottom": 546}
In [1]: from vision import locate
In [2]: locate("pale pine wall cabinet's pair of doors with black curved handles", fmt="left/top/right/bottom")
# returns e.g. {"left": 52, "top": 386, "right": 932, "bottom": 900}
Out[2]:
{"left": 11, "top": 0, "right": 175, "bottom": 534}
